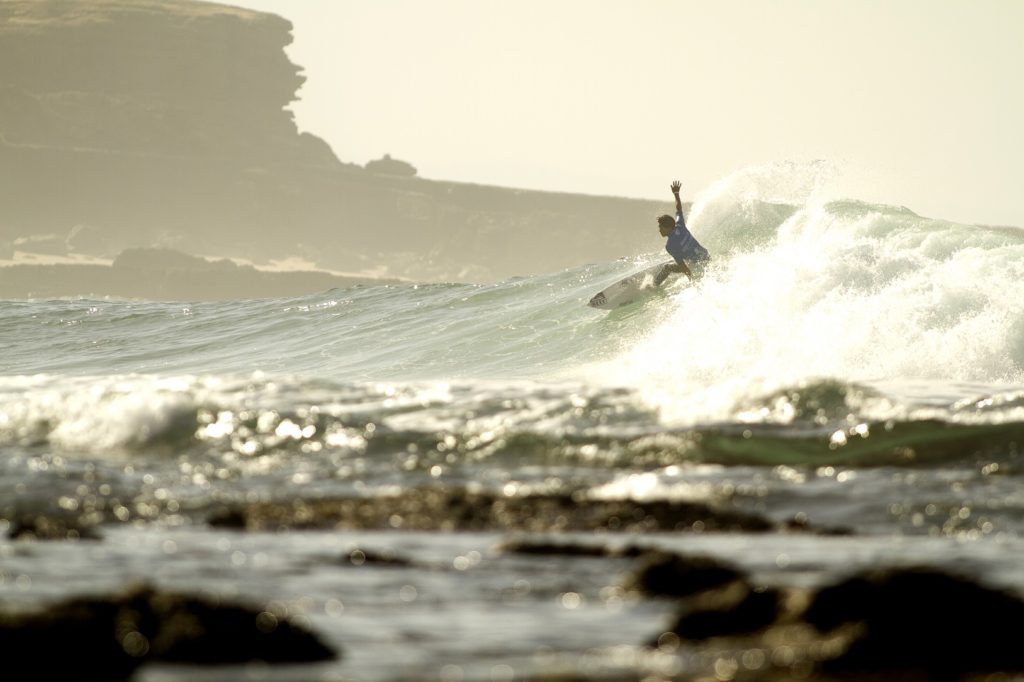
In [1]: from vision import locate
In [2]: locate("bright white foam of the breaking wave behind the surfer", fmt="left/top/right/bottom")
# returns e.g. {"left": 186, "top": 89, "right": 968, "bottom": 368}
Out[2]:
{"left": 601, "top": 163, "right": 1024, "bottom": 422}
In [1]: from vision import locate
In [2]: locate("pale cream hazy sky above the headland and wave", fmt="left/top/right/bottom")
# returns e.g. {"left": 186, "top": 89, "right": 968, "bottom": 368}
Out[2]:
{"left": 220, "top": 0, "right": 1024, "bottom": 226}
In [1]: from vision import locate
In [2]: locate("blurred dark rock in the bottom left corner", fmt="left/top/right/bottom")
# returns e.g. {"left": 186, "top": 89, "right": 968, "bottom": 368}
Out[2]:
{"left": 0, "top": 586, "right": 337, "bottom": 680}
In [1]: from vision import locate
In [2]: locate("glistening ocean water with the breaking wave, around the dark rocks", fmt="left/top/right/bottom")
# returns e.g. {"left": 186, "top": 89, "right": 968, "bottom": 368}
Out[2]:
{"left": 0, "top": 173, "right": 1024, "bottom": 680}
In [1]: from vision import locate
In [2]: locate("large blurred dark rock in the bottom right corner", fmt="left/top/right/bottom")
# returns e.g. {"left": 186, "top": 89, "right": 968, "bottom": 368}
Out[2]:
{"left": 650, "top": 558, "right": 1024, "bottom": 682}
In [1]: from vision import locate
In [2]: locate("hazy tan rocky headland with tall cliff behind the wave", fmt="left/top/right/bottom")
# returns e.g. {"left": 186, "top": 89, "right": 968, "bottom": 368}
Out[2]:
{"left": 0, "top": 0, "right": 672, "bottom": 297}
